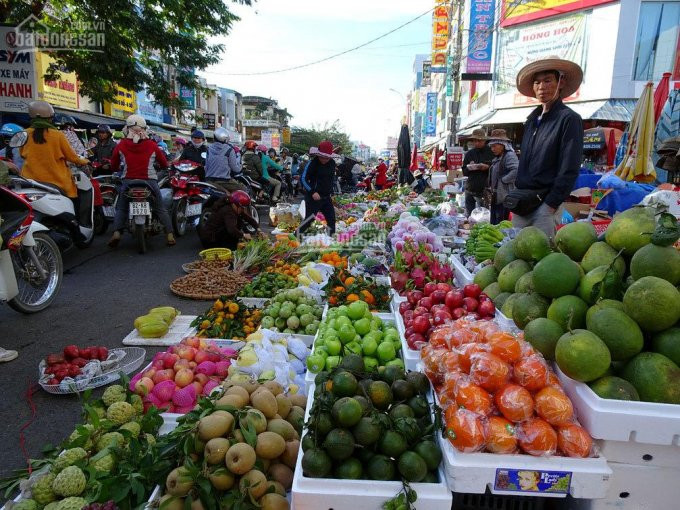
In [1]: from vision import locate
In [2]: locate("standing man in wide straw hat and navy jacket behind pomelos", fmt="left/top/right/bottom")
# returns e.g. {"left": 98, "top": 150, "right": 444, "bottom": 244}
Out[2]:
{"left": 505, "top": 58, "right": 583, "bottom": 237}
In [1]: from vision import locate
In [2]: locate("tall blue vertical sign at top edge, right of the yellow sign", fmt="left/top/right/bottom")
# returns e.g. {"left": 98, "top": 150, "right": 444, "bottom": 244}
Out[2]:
{"left": 467, "top": 0, "right": 495, "bottom": 73}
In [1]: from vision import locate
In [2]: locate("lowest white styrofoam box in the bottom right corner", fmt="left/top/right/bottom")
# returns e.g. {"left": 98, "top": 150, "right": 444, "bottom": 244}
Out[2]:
{"left": 569, "top": 462, "right": 680, "bottom": 510}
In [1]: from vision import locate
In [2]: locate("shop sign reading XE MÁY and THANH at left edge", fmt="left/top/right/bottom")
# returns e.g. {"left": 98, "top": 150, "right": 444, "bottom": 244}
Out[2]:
{"left": 0, "top": 27, "right": 38, "bottom": 113}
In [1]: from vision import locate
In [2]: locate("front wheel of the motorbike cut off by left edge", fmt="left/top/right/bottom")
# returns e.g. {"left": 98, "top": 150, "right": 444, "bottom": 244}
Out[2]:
{"left": 8, "top": 232, "right": 64, "bottom": 314}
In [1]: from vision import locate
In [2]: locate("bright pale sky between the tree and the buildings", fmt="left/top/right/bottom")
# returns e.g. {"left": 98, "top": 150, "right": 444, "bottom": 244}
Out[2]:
{"left": 199, "top": 0, "right": 434, "bottom": 150}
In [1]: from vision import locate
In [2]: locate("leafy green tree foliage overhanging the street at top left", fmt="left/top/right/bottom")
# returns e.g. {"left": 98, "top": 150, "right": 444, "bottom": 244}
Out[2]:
{"left": 0, "top": 0, "right": 252, "bottom": 108}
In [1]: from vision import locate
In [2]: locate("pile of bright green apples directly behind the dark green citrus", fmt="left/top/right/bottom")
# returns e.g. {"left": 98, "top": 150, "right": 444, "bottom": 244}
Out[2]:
{"left": 307, "top": 301, "right": 404, "bottom": 374}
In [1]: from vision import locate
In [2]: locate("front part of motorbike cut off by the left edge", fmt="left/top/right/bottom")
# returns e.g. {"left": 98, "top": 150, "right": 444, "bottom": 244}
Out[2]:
{"left": 0, "top": 186, "right": 64, "bottom": 314}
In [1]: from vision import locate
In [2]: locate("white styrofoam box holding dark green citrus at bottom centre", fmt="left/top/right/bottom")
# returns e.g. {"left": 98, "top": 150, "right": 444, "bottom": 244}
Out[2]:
{"left": 292, "top": 387, "right": 452, "bottom": 510}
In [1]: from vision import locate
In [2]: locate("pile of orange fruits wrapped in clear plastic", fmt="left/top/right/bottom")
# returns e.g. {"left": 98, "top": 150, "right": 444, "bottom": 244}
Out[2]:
{"left": 420, "top": 318, "right": 593, "bottom": 457}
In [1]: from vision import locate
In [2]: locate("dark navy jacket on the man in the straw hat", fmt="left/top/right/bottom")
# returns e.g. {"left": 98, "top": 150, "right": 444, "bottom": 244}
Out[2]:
{"left": 516, "top": 101, "right": 583, "bottom": 209}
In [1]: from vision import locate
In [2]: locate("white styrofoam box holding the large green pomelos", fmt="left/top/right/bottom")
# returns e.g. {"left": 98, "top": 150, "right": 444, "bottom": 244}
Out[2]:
{"left": 555, "top": 366, "right": 680, "bottom": 446}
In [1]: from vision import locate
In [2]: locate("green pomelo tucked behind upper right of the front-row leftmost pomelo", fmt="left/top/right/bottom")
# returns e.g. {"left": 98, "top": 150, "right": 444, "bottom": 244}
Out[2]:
{"left": 587, "top": 308, "right": 645, "bottom": 361}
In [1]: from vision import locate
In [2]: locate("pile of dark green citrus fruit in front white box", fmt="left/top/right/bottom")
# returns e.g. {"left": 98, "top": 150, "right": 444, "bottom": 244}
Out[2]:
{"left": 301, "top": 360, "right": 442, "bottom": 483}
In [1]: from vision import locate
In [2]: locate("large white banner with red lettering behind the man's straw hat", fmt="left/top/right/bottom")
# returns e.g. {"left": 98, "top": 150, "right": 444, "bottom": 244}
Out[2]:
{"left": 496, "top": 14, "right": 587, "bottom": 107}
